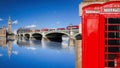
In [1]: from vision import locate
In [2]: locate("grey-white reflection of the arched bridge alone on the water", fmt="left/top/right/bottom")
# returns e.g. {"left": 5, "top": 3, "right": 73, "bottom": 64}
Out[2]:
{"left": 14, "top": 39, "right": 73, "bottom": 49}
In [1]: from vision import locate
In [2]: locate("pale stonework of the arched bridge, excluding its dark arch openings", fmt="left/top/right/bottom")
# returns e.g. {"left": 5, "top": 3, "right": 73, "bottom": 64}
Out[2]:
{"left": 18, "top": 29, "right": 81, "bottom": 39}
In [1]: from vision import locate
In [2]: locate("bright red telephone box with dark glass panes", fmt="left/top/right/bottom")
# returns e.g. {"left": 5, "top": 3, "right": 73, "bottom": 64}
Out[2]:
{"left": 82, "top": 1, "right": 120, "bottom": 68}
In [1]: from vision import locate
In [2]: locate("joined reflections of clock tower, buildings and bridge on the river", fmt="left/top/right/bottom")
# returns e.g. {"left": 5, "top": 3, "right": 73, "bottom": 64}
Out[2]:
{"left": 0, "top": 38, "right": 75, "bottom": 57}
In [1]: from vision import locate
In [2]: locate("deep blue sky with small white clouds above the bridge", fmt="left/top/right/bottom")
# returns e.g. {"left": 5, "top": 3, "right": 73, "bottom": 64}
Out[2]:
{"left": 0, "top": 0, "right": 81, "bottom": 30}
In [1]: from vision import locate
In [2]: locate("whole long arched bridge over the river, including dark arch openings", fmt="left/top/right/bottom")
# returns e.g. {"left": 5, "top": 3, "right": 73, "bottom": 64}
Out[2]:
{"left": 17, "top": 24, "right": 81, "bottom": 44}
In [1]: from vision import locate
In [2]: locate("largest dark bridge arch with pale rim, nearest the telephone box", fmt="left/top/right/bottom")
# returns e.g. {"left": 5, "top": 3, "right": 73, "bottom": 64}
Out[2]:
{"left": 45, "top": 32, "right": 69, "bottom": 42}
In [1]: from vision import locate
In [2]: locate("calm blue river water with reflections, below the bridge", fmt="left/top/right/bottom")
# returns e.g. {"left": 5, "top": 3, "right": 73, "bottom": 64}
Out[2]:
{"left": 0, "top": 39, "right": 76, "bottom": 68}
